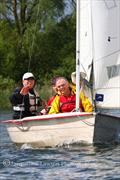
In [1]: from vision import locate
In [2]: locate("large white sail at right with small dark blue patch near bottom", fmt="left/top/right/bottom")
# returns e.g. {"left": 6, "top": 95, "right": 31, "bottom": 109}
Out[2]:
{"left": 91, "top": 0, "right": 120, "bottom": 109}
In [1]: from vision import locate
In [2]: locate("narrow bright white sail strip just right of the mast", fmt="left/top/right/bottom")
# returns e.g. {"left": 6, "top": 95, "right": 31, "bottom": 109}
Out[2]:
{"left": 80, "top": 0, "right": 93, "bottom": 81}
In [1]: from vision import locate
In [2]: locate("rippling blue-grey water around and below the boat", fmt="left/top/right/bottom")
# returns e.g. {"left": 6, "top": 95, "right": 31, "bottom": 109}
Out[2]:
{"left": 0, "top": 113, "right": 120, "bottom": 180}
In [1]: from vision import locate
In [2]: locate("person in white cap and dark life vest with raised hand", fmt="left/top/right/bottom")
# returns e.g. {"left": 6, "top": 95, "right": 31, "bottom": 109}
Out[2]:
{"left": 10, "top": 72, "right": 45, "bottom": 119}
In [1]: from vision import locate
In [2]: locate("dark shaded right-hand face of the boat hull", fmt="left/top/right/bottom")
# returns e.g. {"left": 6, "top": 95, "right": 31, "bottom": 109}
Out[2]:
{"left": 93, "top": 113, "right": 120, "bottom": 144}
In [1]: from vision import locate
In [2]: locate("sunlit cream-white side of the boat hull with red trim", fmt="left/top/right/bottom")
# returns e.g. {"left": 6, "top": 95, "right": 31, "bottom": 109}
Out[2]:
{"left": 5, "top": 112, "right": 95, "bottom": 147}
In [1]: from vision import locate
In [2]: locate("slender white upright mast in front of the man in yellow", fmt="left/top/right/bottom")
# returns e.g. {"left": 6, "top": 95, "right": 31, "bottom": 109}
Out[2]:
{"left": 76, "top": 0, "right": 80, "bottom": 111}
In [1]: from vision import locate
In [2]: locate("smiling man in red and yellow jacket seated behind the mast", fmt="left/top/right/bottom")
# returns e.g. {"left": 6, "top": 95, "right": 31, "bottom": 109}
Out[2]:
{"left": 49, "top": 77, "right": 93, "bottom": 114}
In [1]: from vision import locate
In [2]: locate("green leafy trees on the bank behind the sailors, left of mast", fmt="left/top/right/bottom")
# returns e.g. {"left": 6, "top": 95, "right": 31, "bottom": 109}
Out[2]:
{"left": 0, "top": 0, "right": 76, "bottom": 108}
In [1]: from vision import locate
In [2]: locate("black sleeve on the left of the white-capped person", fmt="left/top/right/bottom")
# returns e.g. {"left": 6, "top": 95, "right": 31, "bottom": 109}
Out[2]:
{"left": 9, "top": 88, "right": 24, "bottom": 105}
